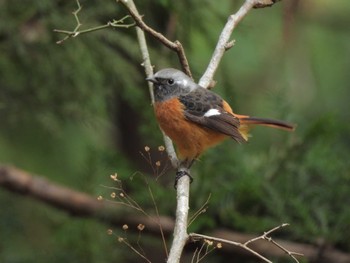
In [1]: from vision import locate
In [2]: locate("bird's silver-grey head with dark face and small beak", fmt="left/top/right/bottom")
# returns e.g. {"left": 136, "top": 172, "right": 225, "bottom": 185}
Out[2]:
{"left": 146, "top": 68, "right": 199, "bottom": 101}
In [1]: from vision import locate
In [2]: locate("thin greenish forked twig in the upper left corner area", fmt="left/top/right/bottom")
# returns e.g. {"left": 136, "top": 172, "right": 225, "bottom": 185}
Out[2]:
{"left": 53, "top": 0, "right": 135, "bottom": 44}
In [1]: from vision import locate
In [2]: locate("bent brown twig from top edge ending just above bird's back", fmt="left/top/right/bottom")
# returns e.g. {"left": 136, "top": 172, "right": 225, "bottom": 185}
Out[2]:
{"left": 116, "top": 0, "right": 192, "bottom": 78}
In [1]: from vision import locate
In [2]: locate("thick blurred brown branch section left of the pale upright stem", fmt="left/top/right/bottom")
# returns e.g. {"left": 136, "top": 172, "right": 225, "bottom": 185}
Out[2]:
{"left": 0, "top": 164, "right": 174, "bottom": 233}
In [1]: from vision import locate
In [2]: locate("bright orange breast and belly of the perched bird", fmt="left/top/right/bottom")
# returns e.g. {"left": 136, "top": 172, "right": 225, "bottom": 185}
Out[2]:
{"left": 154, "top": 98, "right": 227, "bottom": 159}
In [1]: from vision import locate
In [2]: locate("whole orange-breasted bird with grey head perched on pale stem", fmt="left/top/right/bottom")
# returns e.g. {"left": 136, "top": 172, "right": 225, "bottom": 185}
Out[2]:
{"left": 146, "top": 68, "right": 295, "bottom": 171}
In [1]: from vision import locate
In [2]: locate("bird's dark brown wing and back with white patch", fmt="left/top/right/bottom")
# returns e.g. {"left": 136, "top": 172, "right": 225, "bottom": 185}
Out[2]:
{"left": 179, "top": 88, "right": 245, "bottom": 142}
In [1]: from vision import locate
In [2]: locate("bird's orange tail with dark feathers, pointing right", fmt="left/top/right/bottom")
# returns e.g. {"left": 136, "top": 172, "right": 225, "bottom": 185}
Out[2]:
{"left": 236, "top": 115, "right": 296, "bottom": 141}
